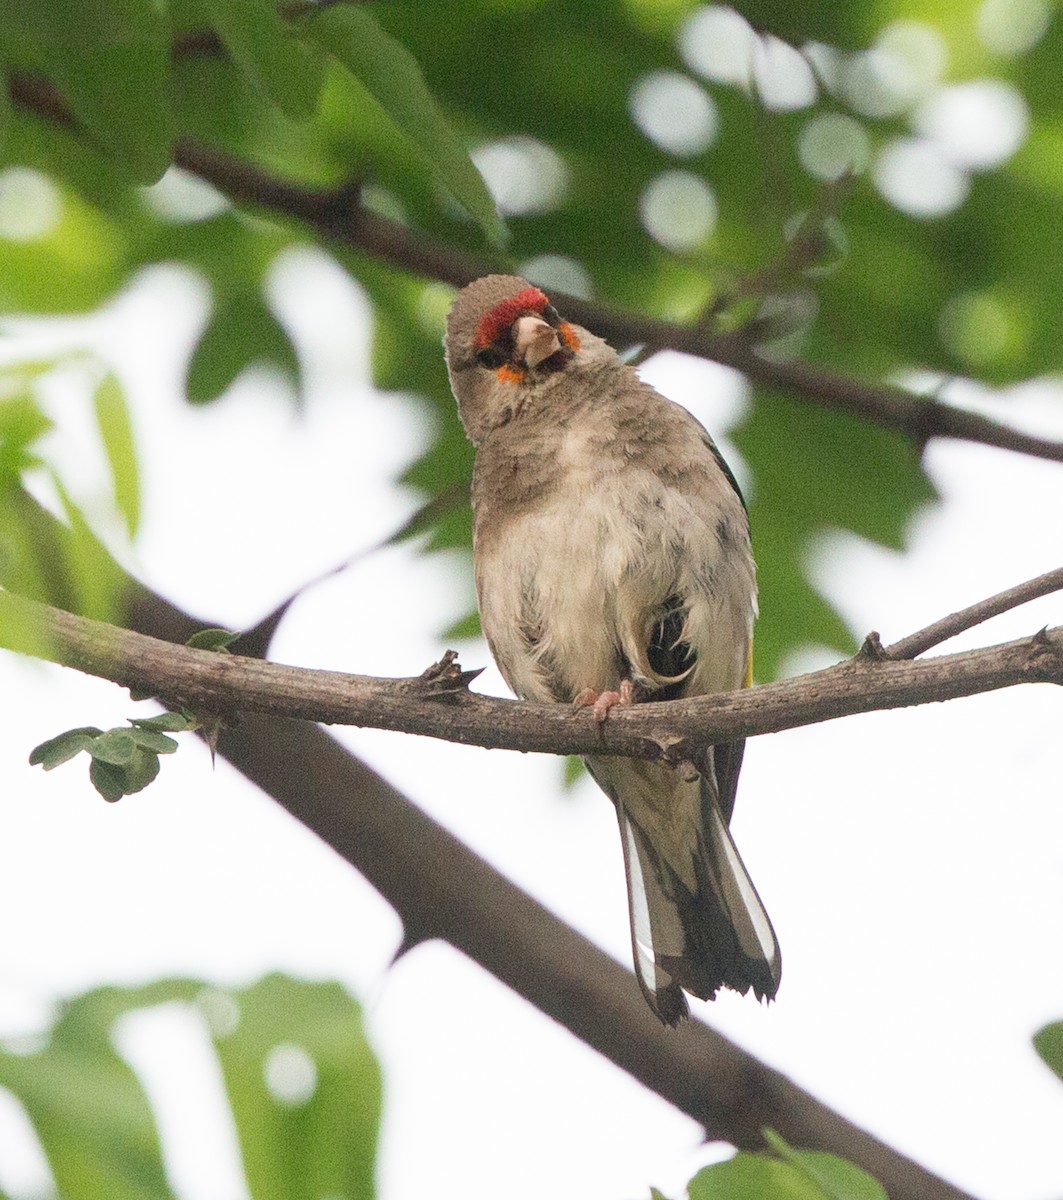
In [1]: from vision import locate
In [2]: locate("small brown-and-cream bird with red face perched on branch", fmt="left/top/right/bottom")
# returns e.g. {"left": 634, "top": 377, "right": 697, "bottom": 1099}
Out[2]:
{"left": 444, "top": 275, "right": 781, "bottom": 1026}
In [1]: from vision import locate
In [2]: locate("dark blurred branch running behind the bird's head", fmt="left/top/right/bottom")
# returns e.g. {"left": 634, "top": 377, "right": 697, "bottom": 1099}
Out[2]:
{"left": 10, "top": 72, "right": 1063, "bottom": 462}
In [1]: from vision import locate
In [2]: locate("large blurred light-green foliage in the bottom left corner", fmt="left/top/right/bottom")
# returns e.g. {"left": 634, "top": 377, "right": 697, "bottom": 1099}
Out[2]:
{"left": 0, "top": 974, "right": 382, "bottom": 1200}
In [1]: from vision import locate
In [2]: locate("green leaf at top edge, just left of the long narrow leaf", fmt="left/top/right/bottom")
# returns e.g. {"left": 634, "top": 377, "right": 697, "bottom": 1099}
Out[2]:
{"left": 202, "top": 0, "right": 323, "bottom": 120}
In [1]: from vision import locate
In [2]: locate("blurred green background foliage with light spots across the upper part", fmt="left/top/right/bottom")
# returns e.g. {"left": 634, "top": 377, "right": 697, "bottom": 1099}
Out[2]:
{"left": 0, "top": 0, "right": 1063, "bottom": 678}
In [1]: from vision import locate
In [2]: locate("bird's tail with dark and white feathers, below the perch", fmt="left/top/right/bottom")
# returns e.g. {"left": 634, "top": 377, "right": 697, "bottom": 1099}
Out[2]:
{"left": 591, "top": 758, "right": 781, "bottom": 1025}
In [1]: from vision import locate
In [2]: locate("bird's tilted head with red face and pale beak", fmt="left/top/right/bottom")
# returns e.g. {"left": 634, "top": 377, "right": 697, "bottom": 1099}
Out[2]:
{"left": 446, "top": 275, "right": 605, "bottom": 444}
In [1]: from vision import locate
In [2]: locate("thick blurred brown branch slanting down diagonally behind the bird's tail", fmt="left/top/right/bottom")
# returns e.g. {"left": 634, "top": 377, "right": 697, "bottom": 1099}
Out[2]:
{"left": 0, "top": 496, "right": 988, "bottom": 1200}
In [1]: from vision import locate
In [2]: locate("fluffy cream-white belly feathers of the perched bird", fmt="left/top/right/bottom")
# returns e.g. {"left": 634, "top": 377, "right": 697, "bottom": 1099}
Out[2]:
{"left": 476, "top": 448, "right": 755, "bottom": 700}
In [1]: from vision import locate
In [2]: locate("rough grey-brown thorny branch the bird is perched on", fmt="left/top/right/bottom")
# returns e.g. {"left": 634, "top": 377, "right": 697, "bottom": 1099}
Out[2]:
{"left": 0, "top": 592, "right": 1063, "bottom": 762}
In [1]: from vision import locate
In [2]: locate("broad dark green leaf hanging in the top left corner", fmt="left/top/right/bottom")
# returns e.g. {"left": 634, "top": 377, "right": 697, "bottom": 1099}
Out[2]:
{"left": 0, "top": 0, "right": 172, "bottom": 184}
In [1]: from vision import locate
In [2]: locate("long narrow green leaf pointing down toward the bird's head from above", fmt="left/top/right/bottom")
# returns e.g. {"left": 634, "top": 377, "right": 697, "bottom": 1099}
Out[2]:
{"left": 306, "top": 5, "right": 505, "bottom": 244}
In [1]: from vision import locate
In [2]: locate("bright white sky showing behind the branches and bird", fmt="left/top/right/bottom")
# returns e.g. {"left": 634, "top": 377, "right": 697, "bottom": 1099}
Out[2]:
{"left": 0, "top": 246, "right": 1063, "bottom": 1200}
